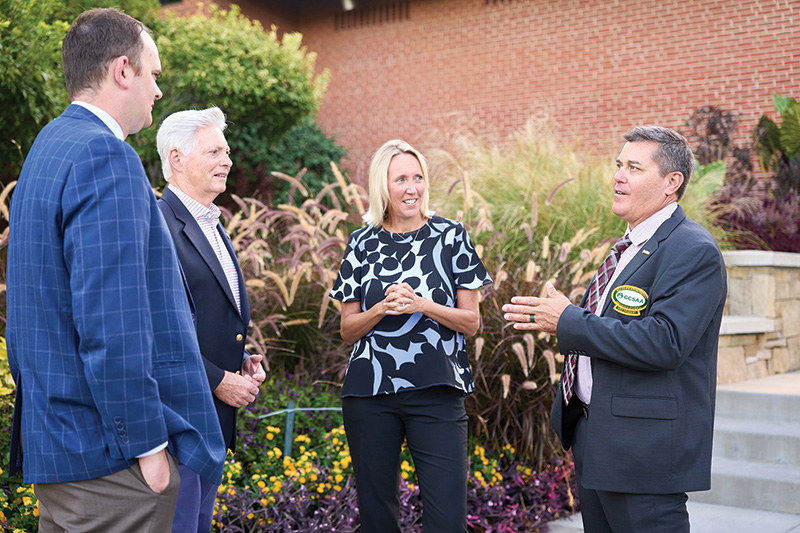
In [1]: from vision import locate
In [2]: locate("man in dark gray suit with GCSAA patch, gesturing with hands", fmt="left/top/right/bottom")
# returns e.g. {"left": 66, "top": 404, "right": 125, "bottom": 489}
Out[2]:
{"left": 503, "top": 126, "right": 726, "bottom": 533}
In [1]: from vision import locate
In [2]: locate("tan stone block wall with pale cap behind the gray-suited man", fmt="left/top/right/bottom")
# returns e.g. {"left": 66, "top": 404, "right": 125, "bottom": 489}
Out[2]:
{"left": 717, "top": 250, "right": 800, "bottom": 385}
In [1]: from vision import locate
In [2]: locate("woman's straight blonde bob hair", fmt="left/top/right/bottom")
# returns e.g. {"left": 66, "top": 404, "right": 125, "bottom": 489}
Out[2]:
{"left": 363, "top": 139, "right": 434, "bottom": 228}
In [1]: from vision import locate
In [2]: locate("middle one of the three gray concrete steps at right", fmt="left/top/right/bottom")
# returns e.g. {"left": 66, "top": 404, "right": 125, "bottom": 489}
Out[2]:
{"left": 714, "top": 417, "right": 800, "bottom": 466}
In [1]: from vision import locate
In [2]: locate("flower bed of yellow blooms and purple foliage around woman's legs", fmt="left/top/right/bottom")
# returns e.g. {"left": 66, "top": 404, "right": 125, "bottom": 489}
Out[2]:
{"left": 214, "top": 426, "right": 575, "bottom": 533}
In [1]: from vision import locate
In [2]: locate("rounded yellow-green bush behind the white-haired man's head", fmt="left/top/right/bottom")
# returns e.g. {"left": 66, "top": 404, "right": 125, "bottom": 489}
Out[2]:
{"left": 132, "top": 5, "right": 328, "bottom": 194}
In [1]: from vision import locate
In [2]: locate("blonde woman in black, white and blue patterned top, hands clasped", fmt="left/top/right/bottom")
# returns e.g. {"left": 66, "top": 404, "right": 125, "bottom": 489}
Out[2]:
{"left": 331, "top": 140, "right": 491, "bottom": 533}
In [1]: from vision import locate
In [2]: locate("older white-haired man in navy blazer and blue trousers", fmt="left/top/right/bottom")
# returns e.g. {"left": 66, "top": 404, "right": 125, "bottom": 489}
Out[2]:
{"left": 157, "top": 107, "right": 266, "bottom": 533}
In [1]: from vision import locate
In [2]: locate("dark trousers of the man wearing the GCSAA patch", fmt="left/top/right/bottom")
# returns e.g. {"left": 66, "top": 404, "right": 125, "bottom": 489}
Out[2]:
{"left": 572, "top": 417, "right": 689, "bottom": 533}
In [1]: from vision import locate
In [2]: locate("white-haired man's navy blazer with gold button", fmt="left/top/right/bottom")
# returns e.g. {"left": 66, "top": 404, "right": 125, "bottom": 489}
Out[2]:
{"left": 158, "top": 188, "right": 250, "bottom": 450}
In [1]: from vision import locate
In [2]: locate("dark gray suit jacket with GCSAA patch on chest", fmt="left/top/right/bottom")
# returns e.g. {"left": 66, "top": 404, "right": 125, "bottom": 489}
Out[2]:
{"left": 552, "top": 207, "right": 727, "bottom": 494}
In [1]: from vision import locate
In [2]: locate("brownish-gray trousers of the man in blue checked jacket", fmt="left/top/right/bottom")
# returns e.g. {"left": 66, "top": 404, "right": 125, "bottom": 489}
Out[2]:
{"left": 34, "top": 453, "right": 181, "bottom": 533}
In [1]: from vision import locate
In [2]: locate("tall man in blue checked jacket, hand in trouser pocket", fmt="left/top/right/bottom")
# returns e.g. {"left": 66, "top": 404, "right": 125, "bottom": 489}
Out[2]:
{"left": 7, "top": 9, "right": 225, "bottom": 532}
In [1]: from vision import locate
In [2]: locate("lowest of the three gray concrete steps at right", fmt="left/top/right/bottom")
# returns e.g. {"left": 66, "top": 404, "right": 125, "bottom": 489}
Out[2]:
{"left": 692, "top": 457, "right": 800, "bottom": 514}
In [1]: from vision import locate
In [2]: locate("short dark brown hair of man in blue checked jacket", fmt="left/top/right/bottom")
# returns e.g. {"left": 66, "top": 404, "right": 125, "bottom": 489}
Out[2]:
{"left": 61, "top": 8, "right": 149, "bottom": 100}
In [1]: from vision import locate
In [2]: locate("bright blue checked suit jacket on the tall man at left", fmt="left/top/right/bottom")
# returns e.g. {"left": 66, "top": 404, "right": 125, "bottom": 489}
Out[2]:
{"left": 6, "top": 105, "right": 226, "bottom": 483}
